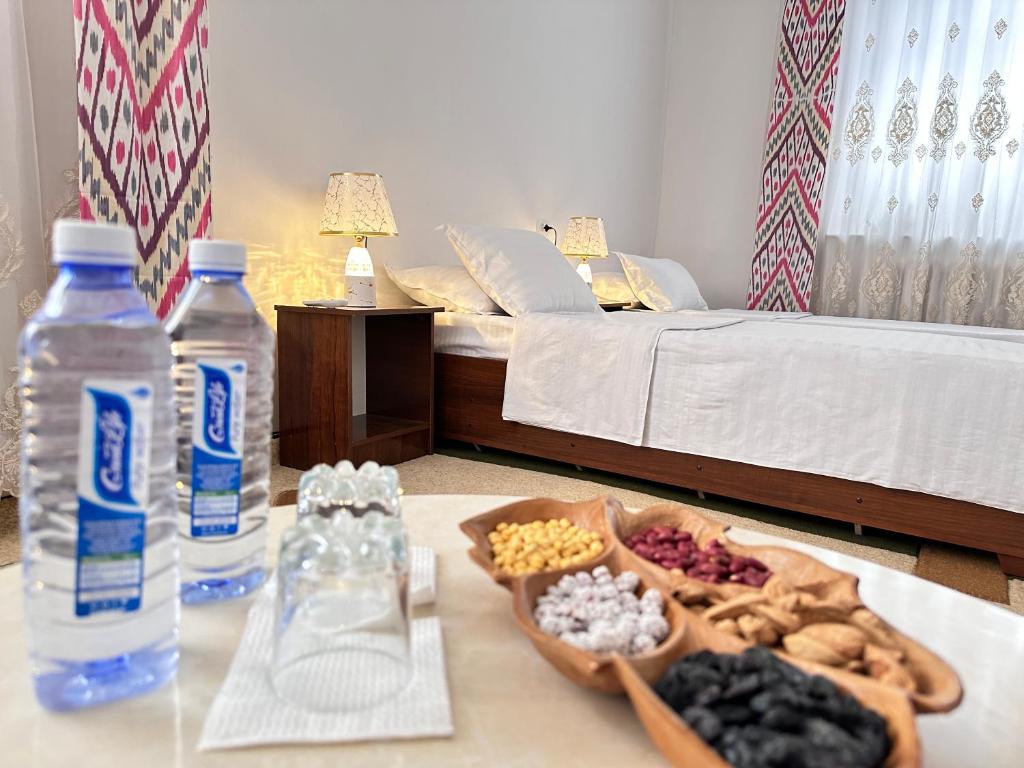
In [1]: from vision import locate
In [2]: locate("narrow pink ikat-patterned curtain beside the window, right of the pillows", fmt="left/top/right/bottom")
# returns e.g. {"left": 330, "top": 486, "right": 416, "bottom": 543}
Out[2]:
{"left": 746, "top": 0, "right": 847, "bottom": 311}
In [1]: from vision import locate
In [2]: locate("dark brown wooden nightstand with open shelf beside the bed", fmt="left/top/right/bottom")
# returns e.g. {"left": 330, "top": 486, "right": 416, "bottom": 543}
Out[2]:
{"left": 274, "top": 305, "right": 443, "bottom": 470}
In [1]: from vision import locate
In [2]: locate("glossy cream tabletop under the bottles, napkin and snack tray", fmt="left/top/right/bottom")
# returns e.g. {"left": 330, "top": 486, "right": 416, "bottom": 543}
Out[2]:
{"left": 0, "top": 496, "right": 1024, "bottom": 768}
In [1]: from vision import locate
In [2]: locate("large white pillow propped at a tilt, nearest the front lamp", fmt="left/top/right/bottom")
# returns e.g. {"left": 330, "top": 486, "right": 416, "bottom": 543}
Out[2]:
{"left": 444, "top": 224, "right": 601, "bottom": 316}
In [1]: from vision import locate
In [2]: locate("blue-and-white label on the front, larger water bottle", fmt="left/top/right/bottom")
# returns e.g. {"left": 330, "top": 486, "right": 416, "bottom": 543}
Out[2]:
{"left": 75, "top": 379, "right": 153, "bottom": 616}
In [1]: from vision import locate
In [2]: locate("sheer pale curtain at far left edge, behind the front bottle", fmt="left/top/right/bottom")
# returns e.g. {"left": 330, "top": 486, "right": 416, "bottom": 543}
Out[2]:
{"left": 0, "top": 0, "right": 78, "bottom": 496}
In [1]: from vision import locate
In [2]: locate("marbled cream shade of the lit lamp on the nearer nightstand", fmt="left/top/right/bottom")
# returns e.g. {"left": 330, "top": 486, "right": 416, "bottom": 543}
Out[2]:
{"left": 321, "top": 171, "right": 398, "bottom": 238}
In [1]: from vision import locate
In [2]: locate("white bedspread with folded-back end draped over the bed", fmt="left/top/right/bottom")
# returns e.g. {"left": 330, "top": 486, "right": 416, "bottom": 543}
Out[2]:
{"left": 505, "top": 312, "right": 1024, "bottom": 514}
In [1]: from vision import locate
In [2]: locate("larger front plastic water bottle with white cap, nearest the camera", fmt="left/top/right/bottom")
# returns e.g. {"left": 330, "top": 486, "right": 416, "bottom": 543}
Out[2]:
{"left": 18, "top": 221, "right": 179, "bottom": 710}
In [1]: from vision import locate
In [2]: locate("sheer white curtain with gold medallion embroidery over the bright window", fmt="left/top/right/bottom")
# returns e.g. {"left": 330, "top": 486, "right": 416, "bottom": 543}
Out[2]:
{"left": 812, "top": 0, "right": 1024, "bottom": 328}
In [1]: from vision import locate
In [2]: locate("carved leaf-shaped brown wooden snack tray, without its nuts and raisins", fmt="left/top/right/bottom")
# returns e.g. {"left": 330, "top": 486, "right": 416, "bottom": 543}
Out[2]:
{"left": 460, "top": 497, "right": 937, "bottom": 768}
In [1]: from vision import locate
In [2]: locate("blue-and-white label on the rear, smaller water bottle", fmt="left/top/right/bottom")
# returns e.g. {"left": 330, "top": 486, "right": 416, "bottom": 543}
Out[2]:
{"left": 191, "top": 359, "right": 248, "bottom": 538}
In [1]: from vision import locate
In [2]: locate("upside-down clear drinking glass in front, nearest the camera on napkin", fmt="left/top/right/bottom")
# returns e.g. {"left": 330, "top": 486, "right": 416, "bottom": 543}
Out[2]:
{"left": 270, "top": 511, "right": 413, "bottom": 712}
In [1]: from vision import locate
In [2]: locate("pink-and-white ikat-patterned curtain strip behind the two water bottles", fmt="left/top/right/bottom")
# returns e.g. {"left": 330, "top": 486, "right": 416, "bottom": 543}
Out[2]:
{"left": 73, "top": 0, "right": 210, "bottom": 317}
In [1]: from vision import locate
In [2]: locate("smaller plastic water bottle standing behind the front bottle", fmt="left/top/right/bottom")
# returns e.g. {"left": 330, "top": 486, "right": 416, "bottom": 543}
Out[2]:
{"left": 167, "top": 240, "right": 274, "bottom": 603}
